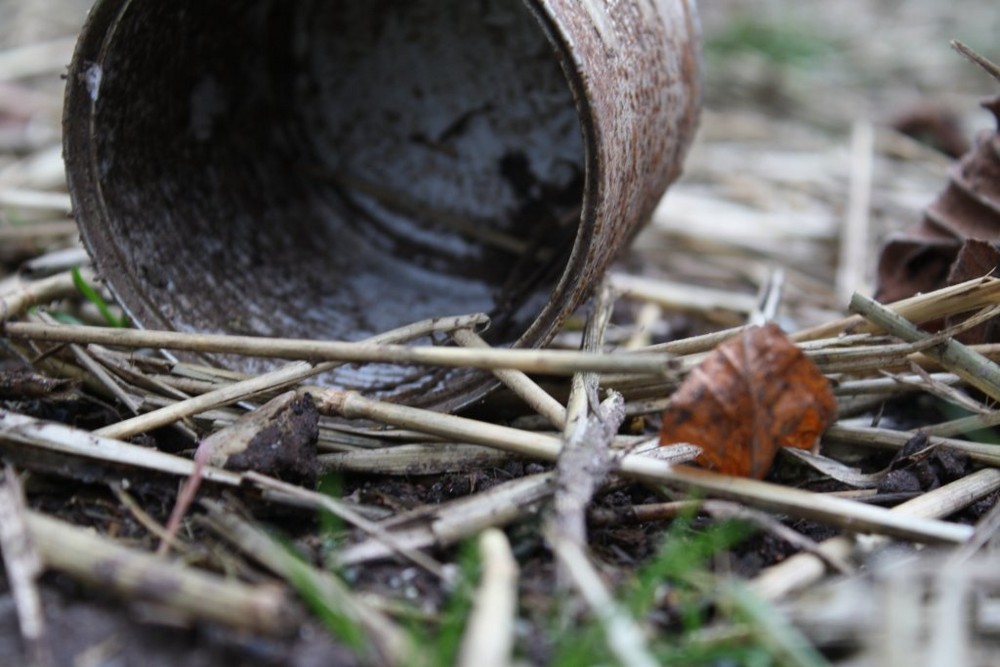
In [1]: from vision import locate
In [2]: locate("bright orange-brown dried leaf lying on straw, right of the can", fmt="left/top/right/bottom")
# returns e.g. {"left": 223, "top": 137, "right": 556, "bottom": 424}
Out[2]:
{"left": 660, "top": 324, "right": 837, "bottom": 479}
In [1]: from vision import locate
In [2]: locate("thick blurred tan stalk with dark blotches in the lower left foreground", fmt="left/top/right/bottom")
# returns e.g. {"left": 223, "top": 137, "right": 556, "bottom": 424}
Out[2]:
{"left": 27, "top": 512, "right": 299, "bottom": 636}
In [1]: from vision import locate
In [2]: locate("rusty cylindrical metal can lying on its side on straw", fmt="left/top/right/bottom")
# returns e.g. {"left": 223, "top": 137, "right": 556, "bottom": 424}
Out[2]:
{"left": 64, "top": 0, "right": 700, "bottom": 409}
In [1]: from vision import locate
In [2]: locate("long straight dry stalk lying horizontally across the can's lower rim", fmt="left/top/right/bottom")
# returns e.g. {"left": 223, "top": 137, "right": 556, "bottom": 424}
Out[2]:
{"left": 3, "top": 322, "right": 672, "bottom": 377}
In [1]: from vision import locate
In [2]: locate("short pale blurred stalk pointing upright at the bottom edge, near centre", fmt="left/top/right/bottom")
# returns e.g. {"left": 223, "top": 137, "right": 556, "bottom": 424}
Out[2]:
{"left": 456, "top": 528, "right": 518, "bottom": 667}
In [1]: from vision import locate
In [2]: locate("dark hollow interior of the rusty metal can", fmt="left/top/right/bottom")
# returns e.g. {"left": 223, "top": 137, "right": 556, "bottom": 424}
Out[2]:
{"left": 78, "top": 0, "right": 584, "bottom": 402}
